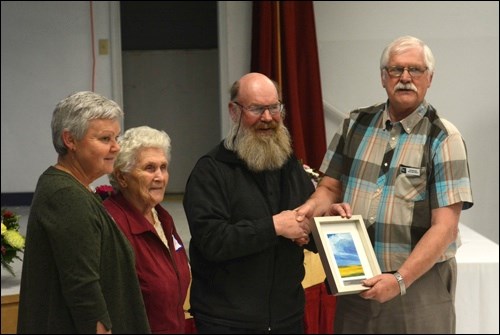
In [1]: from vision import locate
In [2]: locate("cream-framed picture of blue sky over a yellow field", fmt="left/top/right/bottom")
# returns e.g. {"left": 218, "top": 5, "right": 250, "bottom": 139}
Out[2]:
{"left": 312, "top": 215, "right": 381, "bottom": 295}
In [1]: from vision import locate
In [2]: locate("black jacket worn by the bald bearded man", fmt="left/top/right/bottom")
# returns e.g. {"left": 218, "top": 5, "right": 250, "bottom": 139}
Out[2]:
{"left": 184, "top": 142, "right": 315, "bottom": 330}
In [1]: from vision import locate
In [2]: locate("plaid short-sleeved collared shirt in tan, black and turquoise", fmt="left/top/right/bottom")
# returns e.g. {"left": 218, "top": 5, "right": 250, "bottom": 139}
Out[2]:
{"left": 320, "top": 102, "right": 473, "bottom": 272}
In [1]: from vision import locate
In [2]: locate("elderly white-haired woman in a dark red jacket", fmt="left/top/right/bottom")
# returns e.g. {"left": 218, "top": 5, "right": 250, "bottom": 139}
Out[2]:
{"left": 103, "top": 126, "right": 191, "bottom": 334}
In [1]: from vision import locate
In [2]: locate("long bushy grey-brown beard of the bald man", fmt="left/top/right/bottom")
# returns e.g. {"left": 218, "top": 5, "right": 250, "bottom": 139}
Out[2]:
{"left": 233, "top": 123, "right": 292, "bottom": 172}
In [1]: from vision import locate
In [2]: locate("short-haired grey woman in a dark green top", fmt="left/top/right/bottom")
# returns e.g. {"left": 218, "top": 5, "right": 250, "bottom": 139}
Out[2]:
{"left": 17, "top": 92, "right": 150, "bottom": 334}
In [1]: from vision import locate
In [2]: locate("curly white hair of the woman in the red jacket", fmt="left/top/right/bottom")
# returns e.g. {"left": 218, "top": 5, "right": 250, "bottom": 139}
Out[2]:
{"left": 108, "top": 126, "right": 171, "bottom": 189}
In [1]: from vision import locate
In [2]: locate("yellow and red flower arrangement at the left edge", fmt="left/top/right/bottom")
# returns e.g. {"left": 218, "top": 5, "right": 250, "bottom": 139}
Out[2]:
{"left": 2, "top": 209, "right": 24, "bottom": 276}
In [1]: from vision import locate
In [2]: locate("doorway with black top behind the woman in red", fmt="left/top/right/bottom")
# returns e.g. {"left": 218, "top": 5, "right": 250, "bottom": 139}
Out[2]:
{"left": 120, "top": 1, "right": 221, "bottom": 194}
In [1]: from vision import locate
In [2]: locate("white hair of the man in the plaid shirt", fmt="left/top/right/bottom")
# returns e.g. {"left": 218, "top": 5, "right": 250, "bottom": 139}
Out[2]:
{"left": 380, "top": 36, "right": 436, "bottom": 74}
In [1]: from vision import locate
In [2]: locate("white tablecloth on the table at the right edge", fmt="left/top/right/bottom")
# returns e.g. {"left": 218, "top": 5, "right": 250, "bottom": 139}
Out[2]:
{"left": 455, "top": 224, "right": 499, "bottom": 334}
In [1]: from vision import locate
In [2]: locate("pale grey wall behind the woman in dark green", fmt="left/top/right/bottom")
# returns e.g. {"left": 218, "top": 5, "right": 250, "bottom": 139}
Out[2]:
{"left": 1, "top": 1, "right": 119, "bottom": 193}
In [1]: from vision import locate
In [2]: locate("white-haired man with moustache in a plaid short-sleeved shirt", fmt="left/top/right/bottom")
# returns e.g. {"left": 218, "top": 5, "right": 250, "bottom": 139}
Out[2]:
{"left": 298, "top": 36, "right": 473, "bottom": 334}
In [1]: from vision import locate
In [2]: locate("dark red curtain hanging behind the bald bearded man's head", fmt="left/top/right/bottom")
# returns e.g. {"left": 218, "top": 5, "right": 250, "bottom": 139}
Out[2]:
{"left": 251, "top": 1, "right": 326, "bottom": 169}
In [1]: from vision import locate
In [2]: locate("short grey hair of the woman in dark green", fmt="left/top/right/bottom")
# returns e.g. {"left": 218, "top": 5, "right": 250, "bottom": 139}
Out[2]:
{"left": 51, "top": 91, "right": 123, "bottom": 156}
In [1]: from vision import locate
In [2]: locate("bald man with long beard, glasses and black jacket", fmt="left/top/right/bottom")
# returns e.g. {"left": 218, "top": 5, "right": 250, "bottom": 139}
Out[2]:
{"left": 184, "top": 73, "right": 314, "bottom": 334}
